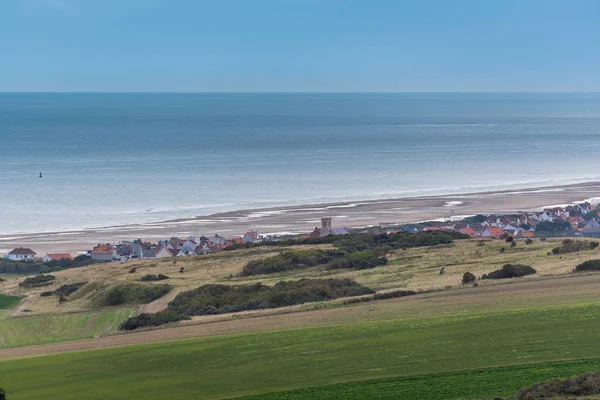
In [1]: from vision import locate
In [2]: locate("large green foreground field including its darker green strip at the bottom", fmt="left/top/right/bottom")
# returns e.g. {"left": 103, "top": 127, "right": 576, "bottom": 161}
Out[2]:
{"left": 0, "top": 302, "right": 600, "bottom": 400}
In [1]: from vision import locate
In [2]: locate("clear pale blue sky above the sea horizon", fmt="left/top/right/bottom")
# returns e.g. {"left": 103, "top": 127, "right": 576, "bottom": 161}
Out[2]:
{"left": 0, "top": 0, "right": 600, "bottom": 92}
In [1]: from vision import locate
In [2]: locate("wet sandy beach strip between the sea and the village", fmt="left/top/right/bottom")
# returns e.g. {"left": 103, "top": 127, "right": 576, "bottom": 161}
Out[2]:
{"left": 0, "top": 182, "right": 600, "bottom": 254}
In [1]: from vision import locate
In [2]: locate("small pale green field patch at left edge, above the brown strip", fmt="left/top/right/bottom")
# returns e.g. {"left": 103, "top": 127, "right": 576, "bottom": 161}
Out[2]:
{"left": 0, "top": 308, "right": 135, "bottom": 348}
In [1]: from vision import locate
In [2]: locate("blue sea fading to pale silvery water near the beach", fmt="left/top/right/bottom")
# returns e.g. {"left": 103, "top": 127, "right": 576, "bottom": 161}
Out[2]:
{"left": 0, "top": 93, "right": 600, "bottom": 234}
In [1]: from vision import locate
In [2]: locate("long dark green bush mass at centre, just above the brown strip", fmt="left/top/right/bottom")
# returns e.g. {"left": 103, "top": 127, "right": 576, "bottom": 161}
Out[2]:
{"left": 167, "top": 279, "right": 373, "bottom": 315}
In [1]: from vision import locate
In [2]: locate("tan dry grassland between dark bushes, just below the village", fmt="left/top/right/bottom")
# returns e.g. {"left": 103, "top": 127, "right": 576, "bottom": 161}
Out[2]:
{"left": 0, "top": 239, "right": 600, "bottom": 316}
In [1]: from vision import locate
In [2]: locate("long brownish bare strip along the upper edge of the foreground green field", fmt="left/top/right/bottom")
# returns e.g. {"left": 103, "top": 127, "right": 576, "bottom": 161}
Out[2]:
{"left": 0, "top": 275, "right": 600, "bottom": 359}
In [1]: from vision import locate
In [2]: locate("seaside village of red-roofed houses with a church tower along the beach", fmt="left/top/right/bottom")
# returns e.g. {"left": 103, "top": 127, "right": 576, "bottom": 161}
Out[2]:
{"left": 3, "top": 202, "right": 600, "bottom": 263}
